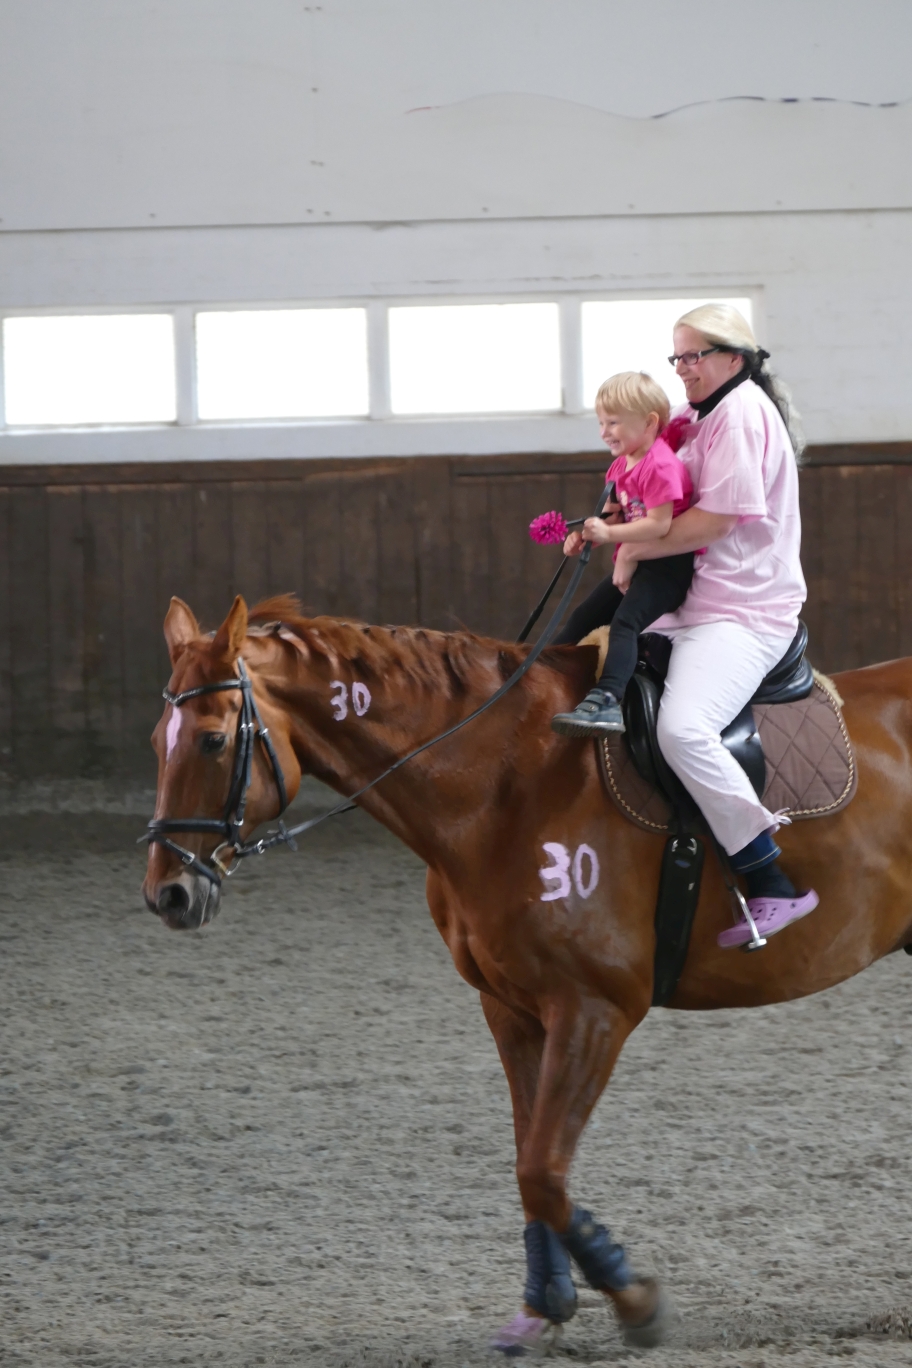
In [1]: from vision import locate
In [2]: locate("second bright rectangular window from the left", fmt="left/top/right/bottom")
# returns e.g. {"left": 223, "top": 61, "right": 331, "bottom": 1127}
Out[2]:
{"left": 196, "top": 309, "right": 368, "bottom": 420}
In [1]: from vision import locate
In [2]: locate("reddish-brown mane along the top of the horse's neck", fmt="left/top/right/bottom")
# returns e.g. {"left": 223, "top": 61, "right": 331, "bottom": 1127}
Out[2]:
{"left": 247, "top": 594, "right": 592, "bottom": 696}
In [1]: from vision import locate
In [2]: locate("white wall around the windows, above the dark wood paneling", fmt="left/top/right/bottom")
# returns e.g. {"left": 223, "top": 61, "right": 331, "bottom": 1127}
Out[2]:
{"left": 0, "top": 0, "right": 912, "bottom": 461}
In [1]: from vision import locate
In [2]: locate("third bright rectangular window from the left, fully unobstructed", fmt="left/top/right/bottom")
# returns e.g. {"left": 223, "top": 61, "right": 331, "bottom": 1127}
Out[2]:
{"left": 390, "top": 304, "right": 561, "bottom": 415}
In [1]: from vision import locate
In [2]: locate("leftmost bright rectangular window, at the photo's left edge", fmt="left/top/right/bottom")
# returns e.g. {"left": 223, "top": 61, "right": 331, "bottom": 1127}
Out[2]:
{"left": 3, "top": 313, "right": 176, "bottom": 427}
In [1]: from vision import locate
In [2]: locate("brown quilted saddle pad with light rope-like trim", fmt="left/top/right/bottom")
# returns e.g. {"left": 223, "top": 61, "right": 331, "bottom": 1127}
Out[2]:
{"left": 596, "top": 676, "right": 859, "bottom": 832}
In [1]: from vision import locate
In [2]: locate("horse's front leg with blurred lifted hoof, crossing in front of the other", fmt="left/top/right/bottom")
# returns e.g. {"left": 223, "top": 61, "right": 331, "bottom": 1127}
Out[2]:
{"left": 517, "top": 995, "right": 666, "bottom": 1347}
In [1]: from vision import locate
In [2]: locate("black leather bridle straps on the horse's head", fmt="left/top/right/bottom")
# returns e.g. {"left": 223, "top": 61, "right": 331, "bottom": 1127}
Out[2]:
{"left": 141, "top": 657, "right": 289, "bottom": 884}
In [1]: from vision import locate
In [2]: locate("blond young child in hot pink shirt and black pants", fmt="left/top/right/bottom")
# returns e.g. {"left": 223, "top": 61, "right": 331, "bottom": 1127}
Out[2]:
{"left": 551, "top": 371, "right": 693, "bottom": 736}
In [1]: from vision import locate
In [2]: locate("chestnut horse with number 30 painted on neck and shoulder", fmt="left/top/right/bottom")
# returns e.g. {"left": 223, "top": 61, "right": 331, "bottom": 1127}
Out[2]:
{"left": 144, "top": 598, "right": 912, "bottom": 1352}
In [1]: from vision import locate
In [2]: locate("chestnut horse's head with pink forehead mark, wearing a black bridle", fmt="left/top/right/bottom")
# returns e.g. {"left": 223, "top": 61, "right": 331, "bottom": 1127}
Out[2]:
{"left": 142, "top": 596, "right": 301, "bottom": 930}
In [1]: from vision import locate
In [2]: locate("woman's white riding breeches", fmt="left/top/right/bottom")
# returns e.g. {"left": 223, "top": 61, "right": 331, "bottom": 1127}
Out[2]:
{"left": 658, "top": 622, "right": 792, "bottom": 855}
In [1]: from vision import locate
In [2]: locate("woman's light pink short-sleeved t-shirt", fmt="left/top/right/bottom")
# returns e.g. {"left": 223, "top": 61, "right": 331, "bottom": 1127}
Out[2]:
{"left": 651, "top": 380, "right": 807, "bottom": 636}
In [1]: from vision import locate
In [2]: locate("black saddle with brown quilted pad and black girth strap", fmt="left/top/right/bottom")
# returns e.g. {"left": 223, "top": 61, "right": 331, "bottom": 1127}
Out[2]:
{"left": 598, "top": 622, "right": 857, "bottom": 1005}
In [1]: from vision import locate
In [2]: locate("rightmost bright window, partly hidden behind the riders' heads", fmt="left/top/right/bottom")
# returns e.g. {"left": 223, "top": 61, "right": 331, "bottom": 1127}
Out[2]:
{"left": 582, "top": 295, "right": 752, "bottom": 408}
